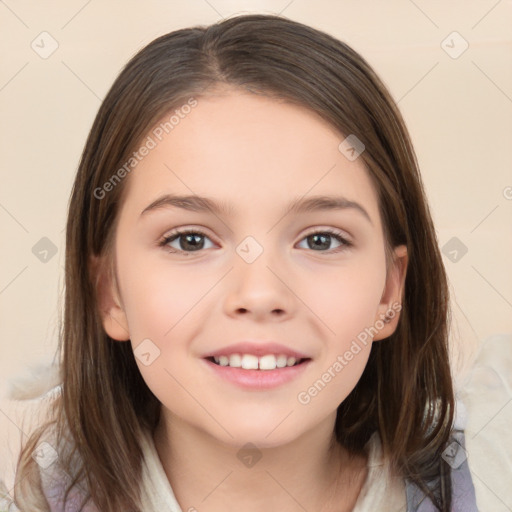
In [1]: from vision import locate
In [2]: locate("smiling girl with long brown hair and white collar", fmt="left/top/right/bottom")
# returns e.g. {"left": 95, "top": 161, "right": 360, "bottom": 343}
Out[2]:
{"left": 10, "top": 15, "right": 476, "bottom": 512}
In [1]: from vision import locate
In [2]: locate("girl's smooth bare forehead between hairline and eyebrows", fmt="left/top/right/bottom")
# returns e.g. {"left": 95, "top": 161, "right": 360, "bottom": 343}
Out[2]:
{"left": 122, "top": 91, "right": 378, "bottom": 226}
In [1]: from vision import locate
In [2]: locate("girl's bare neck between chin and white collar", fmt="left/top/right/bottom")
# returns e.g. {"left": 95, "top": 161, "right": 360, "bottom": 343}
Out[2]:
{"left": 154, "top": 411, "right": 366, "bottom": 512}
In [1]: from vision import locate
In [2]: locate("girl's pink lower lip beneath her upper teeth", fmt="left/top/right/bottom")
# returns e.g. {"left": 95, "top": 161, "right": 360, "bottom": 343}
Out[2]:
{"left": 203, "top": 359, "right": 311, "bottom": 390}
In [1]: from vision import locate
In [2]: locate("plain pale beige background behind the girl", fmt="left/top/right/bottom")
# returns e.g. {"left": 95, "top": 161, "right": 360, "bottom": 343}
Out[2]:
{"left": 0, "top": 0, "right": 512, "bottom": 512}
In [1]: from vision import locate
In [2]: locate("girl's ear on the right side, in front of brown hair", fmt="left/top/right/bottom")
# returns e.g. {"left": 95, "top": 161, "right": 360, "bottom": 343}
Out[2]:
{"left": 373, "top": 245, "right": 408, "bottom": 341}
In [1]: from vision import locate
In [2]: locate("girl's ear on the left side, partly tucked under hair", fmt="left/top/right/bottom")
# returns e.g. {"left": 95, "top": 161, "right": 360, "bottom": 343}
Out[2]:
{"left": 90, "top": 255, "right": 130, "bottom": 341}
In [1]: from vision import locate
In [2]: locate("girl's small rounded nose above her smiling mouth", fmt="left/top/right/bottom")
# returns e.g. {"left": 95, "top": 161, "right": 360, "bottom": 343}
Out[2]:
{"left": 224, "top": 247, "right": 296, "bottom": 321}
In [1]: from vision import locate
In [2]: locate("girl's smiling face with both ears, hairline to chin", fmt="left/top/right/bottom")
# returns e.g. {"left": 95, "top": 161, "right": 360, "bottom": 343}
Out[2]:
{"left": 96, "top": 90, "right": 407, "bottom": 447}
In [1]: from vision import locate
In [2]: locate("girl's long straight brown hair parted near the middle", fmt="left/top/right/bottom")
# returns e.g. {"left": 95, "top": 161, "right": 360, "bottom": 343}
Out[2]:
{"left": 15, "top": 15, "right": 454, "bottom": 512}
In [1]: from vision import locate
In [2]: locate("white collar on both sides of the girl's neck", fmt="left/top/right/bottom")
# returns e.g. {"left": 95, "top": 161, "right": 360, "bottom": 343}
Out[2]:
{"left": 138, "top": 432, "right": 407, "bottom": 512}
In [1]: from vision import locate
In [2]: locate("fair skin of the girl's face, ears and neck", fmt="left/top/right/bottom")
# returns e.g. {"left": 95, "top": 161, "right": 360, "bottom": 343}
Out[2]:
{"left": 94, "top": 90, "right": 407, "bottom": 512}
